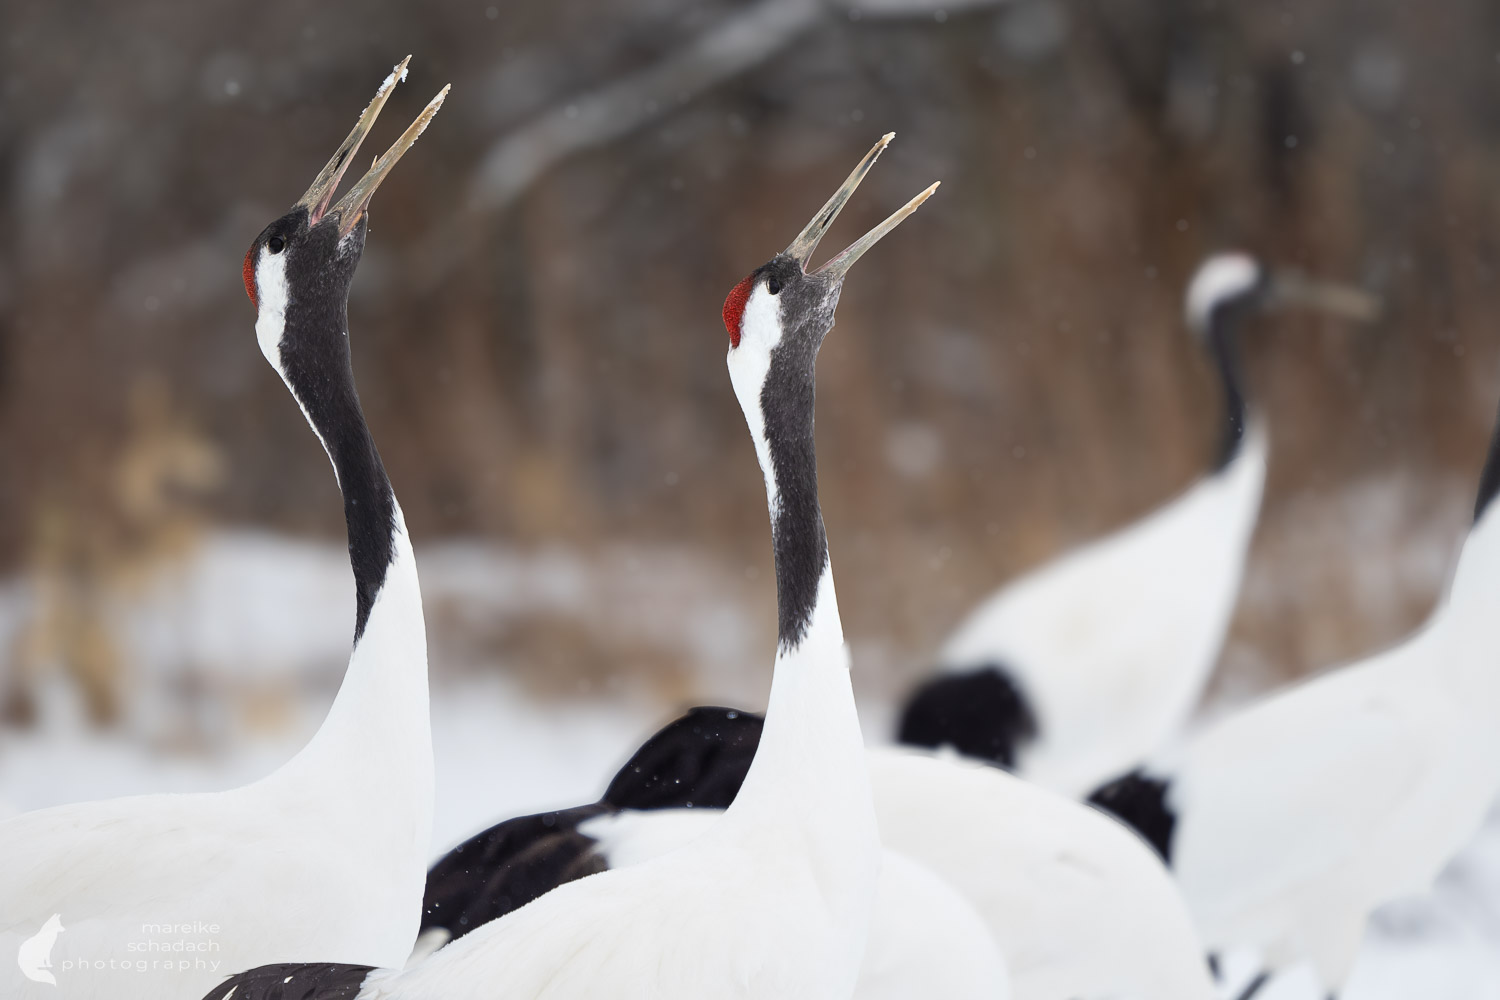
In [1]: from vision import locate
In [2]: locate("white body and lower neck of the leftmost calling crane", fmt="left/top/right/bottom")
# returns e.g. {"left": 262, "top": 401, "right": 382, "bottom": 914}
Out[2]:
{"left": 0, "top": 531, "right": 432, "bottom": 1000}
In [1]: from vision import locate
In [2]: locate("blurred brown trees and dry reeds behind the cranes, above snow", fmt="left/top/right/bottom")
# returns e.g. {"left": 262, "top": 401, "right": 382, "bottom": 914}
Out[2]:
{"left": 0, "top": 0, "right": 1500, "bottom": 734}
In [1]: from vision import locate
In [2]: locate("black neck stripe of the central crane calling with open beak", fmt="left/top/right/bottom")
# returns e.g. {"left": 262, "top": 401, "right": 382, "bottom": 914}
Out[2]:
{"left": 761, "top": 345, "right": 828, "bottom": 649}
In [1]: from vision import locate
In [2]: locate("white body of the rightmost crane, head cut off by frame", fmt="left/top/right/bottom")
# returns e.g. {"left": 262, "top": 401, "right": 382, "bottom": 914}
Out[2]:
{"left": 1116, "top": 434, "right": 1500, "bottom": 990}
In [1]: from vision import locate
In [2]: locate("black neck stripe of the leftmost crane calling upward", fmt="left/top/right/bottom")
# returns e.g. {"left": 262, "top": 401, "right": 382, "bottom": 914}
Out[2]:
{"left": 281, "top": 300, "right": 396, "bottom": 643}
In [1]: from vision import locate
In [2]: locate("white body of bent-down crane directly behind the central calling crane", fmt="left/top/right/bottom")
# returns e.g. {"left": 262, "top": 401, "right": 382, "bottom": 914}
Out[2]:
{"left": 869, "top": 747, "right": 1214, "bottom": 1000}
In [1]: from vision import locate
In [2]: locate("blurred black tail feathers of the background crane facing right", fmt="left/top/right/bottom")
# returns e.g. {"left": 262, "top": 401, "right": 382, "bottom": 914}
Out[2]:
{"left": 896, "top": 663, "right": 1037, "bottom": 768}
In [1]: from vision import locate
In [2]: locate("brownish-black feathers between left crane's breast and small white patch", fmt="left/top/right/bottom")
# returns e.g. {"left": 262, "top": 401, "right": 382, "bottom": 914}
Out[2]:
{"left": 422, "top": 804, "right": 612, "bottom": 939}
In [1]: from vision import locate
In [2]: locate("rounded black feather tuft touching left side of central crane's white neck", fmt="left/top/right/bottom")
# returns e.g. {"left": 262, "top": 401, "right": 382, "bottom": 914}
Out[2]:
{"left": 603, "top": 706, "right": 765, "bottom": 810}
